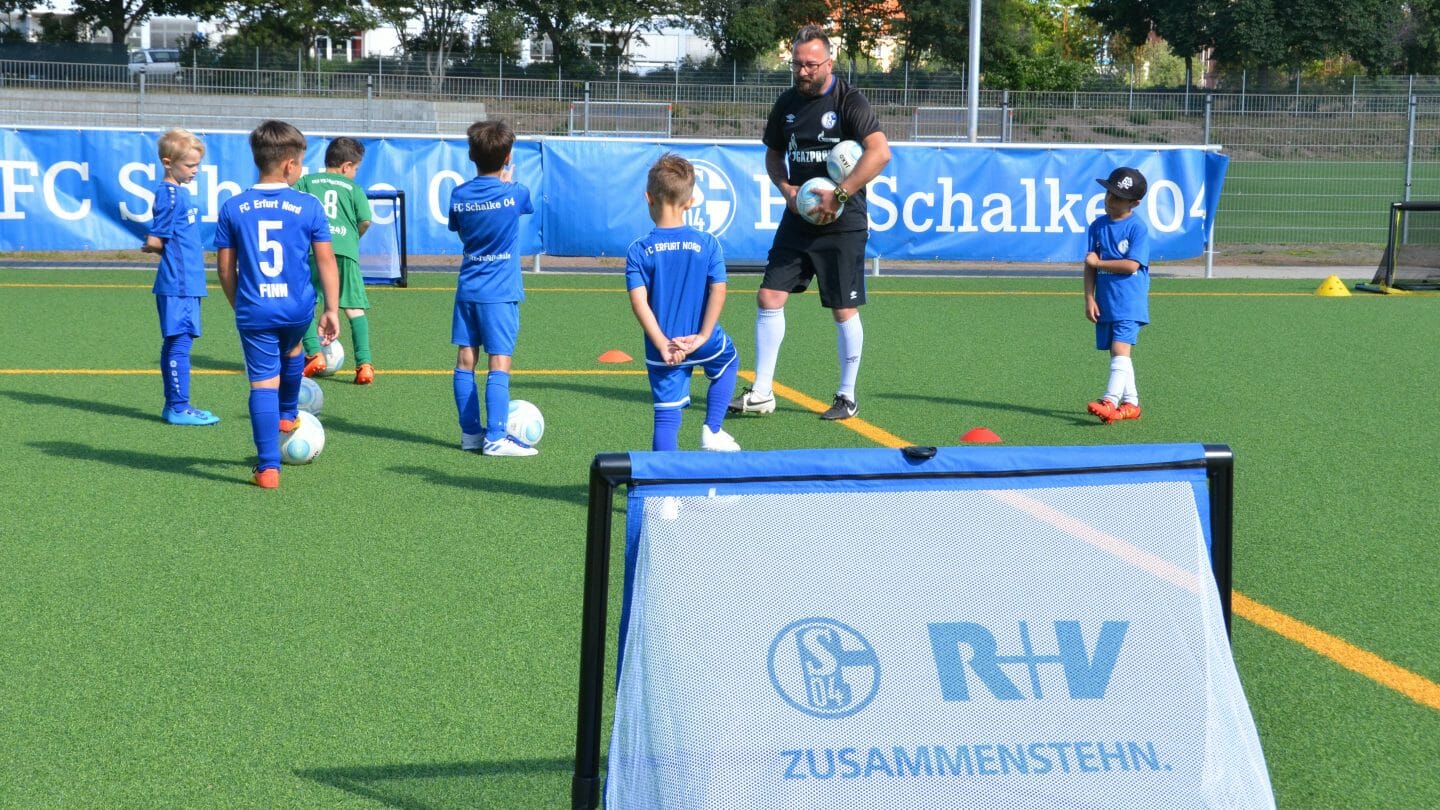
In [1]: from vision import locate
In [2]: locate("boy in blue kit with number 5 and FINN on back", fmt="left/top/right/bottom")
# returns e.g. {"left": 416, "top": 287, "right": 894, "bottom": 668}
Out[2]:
{"left": 215, "top": 121, "right": 340, "bottom": 489}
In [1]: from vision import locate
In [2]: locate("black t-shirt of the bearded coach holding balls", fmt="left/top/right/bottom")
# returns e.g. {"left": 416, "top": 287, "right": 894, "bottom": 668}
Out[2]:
{"left": 760, "top": 76, "right": 880, "bottom": 233}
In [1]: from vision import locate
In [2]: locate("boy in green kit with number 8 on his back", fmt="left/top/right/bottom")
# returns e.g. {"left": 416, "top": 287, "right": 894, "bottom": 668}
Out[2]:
{"left": 295, "top": 137, "right": 374, "bottom": 385}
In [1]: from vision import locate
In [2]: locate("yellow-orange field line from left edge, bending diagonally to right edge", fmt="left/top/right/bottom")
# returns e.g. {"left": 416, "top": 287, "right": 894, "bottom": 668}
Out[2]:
{"left": 0, "top": 369, "right": 1440, "bottom": 711}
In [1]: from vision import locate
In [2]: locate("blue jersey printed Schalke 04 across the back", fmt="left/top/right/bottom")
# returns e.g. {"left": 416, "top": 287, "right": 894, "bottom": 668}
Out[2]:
{"left": 449, "top": 176, "right": 534, "bottom": 304}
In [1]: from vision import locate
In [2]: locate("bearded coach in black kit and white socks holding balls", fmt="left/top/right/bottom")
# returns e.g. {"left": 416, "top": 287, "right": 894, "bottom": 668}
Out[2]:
{"left": 730, "top": 26, "right": 890, "bottom": 419}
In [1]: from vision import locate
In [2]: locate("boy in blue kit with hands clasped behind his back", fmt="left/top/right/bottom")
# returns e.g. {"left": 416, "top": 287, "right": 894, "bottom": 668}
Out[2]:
{"left": 625, "top": 154, "right": 740, "bottom": 453}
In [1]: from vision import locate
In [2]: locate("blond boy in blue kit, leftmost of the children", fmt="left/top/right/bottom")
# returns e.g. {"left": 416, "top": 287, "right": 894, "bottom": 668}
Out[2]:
{"left": 140, "top": 130, "right": 220, "bottom": 425}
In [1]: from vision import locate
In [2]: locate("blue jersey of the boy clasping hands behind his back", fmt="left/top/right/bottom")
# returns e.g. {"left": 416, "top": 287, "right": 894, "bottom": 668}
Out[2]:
{"left": 625, "top": 225, "right": 726, "bottom": 362}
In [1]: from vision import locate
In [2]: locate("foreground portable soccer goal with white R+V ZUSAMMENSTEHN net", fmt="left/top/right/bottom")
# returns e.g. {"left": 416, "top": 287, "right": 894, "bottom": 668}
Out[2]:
{"left": 572, "top": 444, "right": 1274, "bottom": 810}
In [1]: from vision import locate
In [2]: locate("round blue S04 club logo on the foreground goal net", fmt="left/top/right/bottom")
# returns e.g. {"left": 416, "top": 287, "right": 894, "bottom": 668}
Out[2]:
{"left": 770, "top": 618, "right": 880, "bottom": 718}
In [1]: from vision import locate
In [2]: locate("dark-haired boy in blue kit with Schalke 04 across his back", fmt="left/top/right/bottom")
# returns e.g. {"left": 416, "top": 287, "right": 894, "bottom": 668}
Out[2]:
{"left": 449, "top": 121, "right": 539, "bottom": 455}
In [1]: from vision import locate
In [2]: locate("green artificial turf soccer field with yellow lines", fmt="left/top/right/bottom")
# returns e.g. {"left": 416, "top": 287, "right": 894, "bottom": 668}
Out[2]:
{"left": 0, "top": 270, "right": 1440, "bottom": 809}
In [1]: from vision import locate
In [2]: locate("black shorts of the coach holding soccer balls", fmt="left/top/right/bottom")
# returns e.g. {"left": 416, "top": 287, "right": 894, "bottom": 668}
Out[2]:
{"left": 760, "top": 226, "right": 870, "bottom": 310}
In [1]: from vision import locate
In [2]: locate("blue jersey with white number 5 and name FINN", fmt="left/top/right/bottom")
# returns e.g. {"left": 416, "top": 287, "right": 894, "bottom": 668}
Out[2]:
{"left": 215, "top": 183, "right": 330, "bottom": 330}
